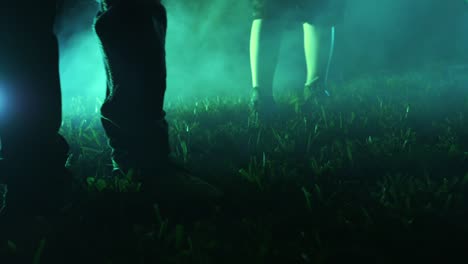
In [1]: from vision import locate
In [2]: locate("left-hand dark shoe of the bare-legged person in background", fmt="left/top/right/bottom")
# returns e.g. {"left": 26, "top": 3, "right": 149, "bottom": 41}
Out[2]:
{"left": 250, "top": 87, "right": 277, "bottom": 119}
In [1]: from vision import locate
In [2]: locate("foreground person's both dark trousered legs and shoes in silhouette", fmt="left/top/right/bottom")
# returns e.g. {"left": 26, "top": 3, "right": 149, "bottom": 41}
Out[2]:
{"left": 0, "top": 0, "right": 219, "bottom": 219}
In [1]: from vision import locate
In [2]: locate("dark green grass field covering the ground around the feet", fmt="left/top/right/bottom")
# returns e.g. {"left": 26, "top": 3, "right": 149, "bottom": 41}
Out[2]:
{"left": 1, "top": 69, "right": 468, "bottom": 264}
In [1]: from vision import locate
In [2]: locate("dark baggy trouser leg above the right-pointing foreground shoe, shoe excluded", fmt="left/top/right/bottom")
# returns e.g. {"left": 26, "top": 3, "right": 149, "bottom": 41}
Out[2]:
{"left": 95, "top": 1, "right": 169, "bottom": 171}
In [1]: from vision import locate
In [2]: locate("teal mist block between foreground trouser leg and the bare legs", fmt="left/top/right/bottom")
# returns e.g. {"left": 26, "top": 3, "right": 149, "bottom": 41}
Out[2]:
{"left": 166, "top": 0, "right": 250, "bottom": 101}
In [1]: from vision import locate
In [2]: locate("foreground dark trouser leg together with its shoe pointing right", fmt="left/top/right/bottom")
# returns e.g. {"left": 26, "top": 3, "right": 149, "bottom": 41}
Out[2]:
{"left": 95, "top": 1, "right": 221, "bottom": 205}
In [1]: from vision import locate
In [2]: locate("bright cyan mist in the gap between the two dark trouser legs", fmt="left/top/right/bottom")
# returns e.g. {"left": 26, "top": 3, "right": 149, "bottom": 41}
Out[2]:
{"left": 55, "top": 0, "right": 106, "bottom": 108}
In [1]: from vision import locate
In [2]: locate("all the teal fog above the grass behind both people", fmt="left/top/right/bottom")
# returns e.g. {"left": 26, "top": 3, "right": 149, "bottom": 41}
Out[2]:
{"left": 56, "top": 0, "right": 468, "bottom": 110}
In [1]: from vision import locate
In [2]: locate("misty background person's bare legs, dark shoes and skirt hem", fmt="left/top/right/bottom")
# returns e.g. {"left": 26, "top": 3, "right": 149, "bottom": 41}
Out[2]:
{"left": 250, "top": 0, "right": 344, "bottom": 114}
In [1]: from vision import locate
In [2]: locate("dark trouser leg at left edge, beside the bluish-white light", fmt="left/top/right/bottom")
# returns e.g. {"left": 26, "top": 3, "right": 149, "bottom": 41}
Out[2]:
{"left": 0, "top": 1, "right": 68, "bottom": 210}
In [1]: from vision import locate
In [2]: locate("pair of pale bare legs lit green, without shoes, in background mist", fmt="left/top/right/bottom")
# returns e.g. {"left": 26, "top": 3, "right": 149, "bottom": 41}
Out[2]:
{"left": 250, "top": 19, "right": 319, "bottom": 102}
